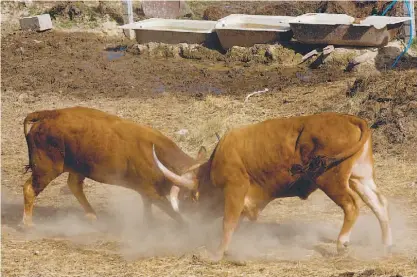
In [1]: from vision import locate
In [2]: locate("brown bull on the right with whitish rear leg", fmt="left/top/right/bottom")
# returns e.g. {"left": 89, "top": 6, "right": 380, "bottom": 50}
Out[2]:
{"left": 154, "top": 113, "right": 392, "bottom": 259}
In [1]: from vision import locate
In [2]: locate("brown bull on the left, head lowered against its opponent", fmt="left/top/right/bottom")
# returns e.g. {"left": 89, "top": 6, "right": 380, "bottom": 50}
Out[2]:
{"left": 23, "top": 107, "right": 205, "bottom": 226}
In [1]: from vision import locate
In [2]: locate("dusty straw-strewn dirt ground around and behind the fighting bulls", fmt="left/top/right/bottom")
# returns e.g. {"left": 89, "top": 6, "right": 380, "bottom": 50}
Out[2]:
{"left": 1, "top": 1, "right": 417, "bottom": 277}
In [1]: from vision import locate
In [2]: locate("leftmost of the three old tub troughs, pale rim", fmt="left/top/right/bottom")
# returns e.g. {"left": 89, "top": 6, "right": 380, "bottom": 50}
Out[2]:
{"left": 120, "top": 18, "right": 216, "bottom": 44}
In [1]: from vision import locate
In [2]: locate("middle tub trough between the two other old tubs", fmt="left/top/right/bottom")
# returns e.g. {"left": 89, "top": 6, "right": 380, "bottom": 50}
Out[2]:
{"left": 216, "top": 14, "right": 295, "bottom": 49}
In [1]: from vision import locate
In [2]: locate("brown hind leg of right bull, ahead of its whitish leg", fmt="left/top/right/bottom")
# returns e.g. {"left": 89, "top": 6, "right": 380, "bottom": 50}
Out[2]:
{"left": 320, "top": 174, "right": 360, "bottom": 254}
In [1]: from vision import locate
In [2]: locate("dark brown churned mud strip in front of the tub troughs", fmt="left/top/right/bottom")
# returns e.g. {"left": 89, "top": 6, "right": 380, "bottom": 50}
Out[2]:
{"left": 1, "top": 31, "right": 349, "bottom": 99}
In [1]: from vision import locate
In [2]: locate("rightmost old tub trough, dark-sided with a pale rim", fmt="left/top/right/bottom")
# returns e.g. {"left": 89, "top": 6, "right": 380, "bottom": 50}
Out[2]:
{"left": 289, "top": 13, "right": 410, "bottom": 47}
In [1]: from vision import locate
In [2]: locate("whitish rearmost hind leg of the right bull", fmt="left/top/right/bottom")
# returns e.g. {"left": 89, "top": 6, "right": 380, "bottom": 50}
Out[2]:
{"left": 350, "top": 177, "right": 392, "bottom": 252}
